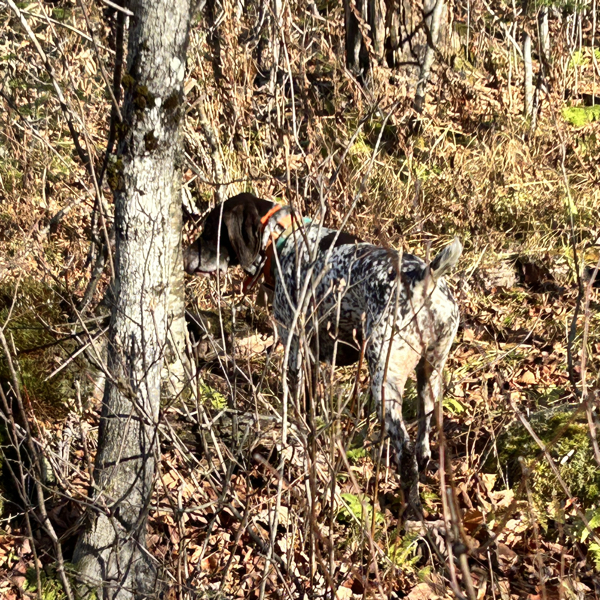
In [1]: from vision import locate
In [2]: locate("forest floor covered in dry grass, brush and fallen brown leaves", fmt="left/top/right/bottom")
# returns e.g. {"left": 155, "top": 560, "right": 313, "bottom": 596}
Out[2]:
{"left": 0, "top": 2, "right": 600, "bottom": 600}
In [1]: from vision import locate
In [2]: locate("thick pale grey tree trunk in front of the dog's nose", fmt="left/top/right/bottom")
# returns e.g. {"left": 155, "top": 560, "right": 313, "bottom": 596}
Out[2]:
{"left": 74, "top": 0, "right": 191, "bottom": 599}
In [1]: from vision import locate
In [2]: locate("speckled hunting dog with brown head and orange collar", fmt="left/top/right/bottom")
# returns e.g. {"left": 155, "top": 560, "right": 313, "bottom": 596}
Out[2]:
{"left": 184, "top": 194, "right": 462, "bottom": 516}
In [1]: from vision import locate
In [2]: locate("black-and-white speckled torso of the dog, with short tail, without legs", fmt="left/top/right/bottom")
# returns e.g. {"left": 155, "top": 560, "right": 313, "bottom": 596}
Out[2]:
{"left": 273, "top": 225, "right": 462, "bottom": 364}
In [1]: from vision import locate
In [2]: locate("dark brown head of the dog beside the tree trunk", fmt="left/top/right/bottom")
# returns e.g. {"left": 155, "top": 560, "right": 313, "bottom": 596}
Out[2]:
{"left": 183, "top": 194, "right": 273, "bottom": 274}
